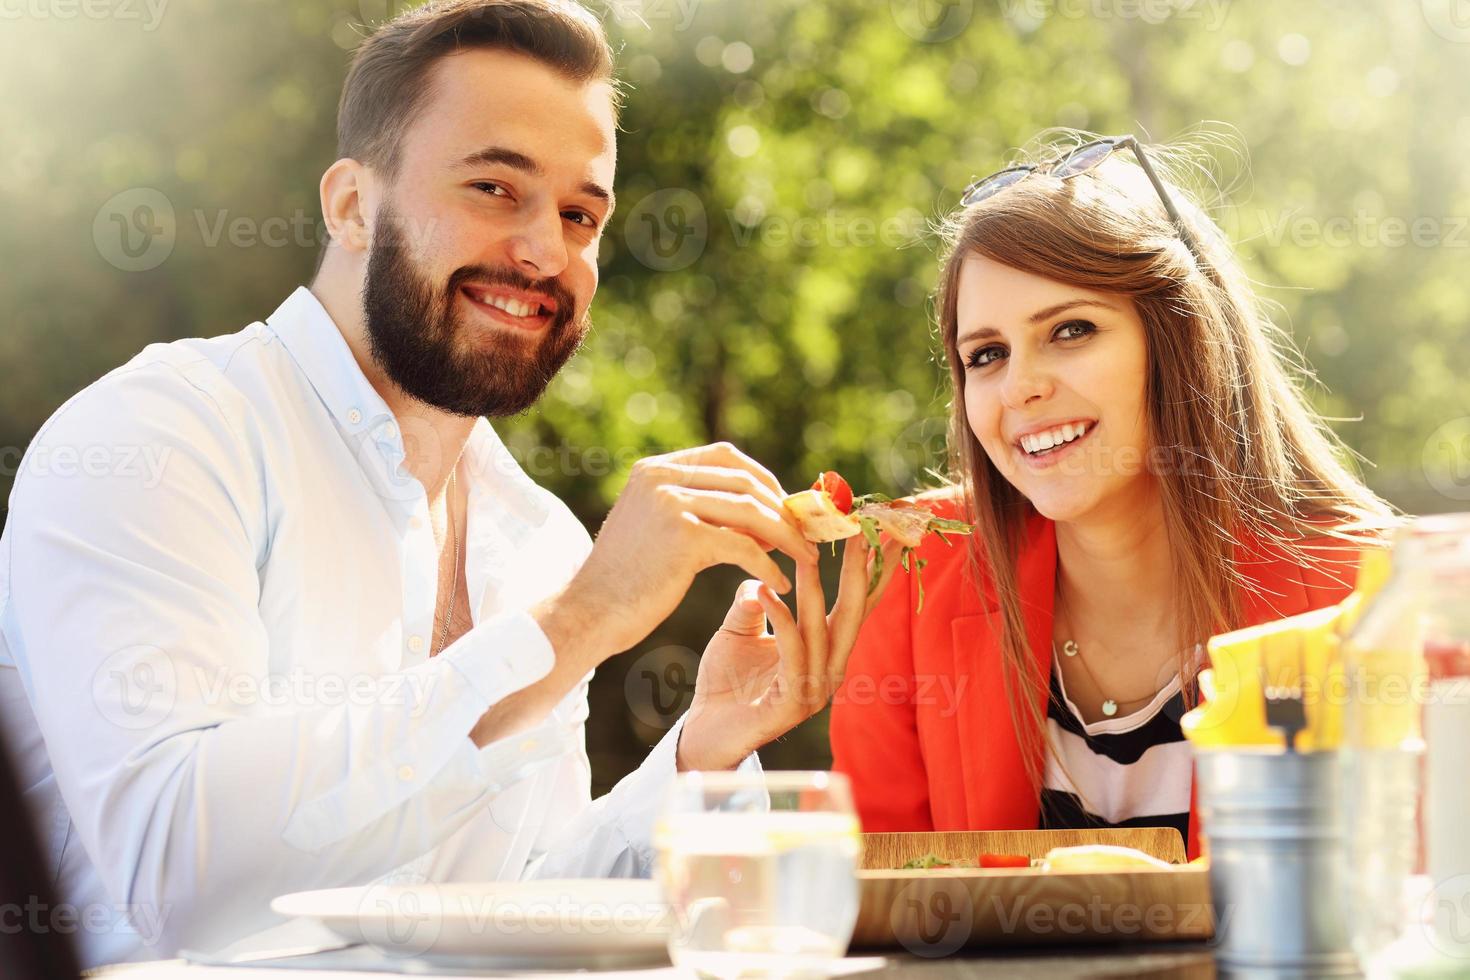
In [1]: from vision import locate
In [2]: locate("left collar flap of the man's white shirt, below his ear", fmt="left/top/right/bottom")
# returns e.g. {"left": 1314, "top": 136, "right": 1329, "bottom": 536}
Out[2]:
{"left": 266, "top": 287, "right": 392, "bottom": 432}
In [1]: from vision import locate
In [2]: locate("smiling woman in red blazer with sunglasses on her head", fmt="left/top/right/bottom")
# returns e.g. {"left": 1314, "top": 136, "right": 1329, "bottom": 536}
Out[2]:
{"left": 831, "top": 130, "right": 1394, "bottom": 857}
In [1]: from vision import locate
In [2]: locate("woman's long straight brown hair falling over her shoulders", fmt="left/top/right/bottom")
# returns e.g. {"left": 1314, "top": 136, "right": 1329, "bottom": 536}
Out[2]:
{"left": 938, "top": 131, "right": 1397, "bottom": 786}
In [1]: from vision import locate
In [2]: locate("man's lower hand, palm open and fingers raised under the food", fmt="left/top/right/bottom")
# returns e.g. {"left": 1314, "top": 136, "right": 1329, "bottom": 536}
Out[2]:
{"left": 678, "top": 535, "right": 900, "bottom": 770}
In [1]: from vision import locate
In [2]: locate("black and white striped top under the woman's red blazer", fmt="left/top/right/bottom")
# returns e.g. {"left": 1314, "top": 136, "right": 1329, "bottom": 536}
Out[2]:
{"left": 1039, "top": 664, "right": 1194, "bottom": 842}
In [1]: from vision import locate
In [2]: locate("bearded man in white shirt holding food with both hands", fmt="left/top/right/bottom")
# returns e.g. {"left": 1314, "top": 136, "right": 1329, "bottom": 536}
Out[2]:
{"left": 0, "top": 0, "right": 895, "bottom": 965}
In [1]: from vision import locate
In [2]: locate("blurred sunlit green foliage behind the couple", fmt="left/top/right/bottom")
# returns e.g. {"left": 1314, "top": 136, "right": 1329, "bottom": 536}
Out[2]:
{"left": 0, "top": 0, "right": 1470, "bottom": 788}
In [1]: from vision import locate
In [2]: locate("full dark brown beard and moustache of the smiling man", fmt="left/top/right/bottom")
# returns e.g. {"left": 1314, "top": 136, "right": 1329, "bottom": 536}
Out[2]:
{"left": 362, "top": 204, "right": 589, "bottom": 417}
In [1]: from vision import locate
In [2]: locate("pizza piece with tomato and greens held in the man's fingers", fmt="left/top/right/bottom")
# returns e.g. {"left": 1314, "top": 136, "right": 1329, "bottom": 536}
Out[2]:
{"left": 782, "top": 472, "right": 972, "bottom": 610}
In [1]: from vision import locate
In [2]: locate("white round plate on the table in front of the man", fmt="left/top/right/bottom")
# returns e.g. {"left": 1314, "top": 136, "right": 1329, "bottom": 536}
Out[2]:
{"left": 270, "top": 879, "right": 670, "bottom": 968}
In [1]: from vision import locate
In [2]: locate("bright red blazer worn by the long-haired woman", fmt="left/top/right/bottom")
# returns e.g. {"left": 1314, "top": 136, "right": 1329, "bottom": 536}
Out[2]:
{"left": 831, "top": 501, "right": 1357, "bottom": 858}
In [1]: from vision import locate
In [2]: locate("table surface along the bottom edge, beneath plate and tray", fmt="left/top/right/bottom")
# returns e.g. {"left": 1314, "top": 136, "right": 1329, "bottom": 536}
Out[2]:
{"left": 90, "top": 943, "right": 1216, "bottom": 980}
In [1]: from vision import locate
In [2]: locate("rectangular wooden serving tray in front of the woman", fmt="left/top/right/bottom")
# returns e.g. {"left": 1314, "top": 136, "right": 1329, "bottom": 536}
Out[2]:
{"left": 853, "top": 827, "right": 1214, "bottom": 956}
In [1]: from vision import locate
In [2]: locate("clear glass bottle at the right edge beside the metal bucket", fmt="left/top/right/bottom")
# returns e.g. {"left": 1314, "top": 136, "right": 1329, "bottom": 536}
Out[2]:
{"left": 1342, "top": 514, "right": 1470, "bottom": 977}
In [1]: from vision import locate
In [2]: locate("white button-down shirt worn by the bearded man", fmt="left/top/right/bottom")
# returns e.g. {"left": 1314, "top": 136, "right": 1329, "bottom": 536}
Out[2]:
{"left": 0, "top": 288, "right": 759, "bottom": 965}
